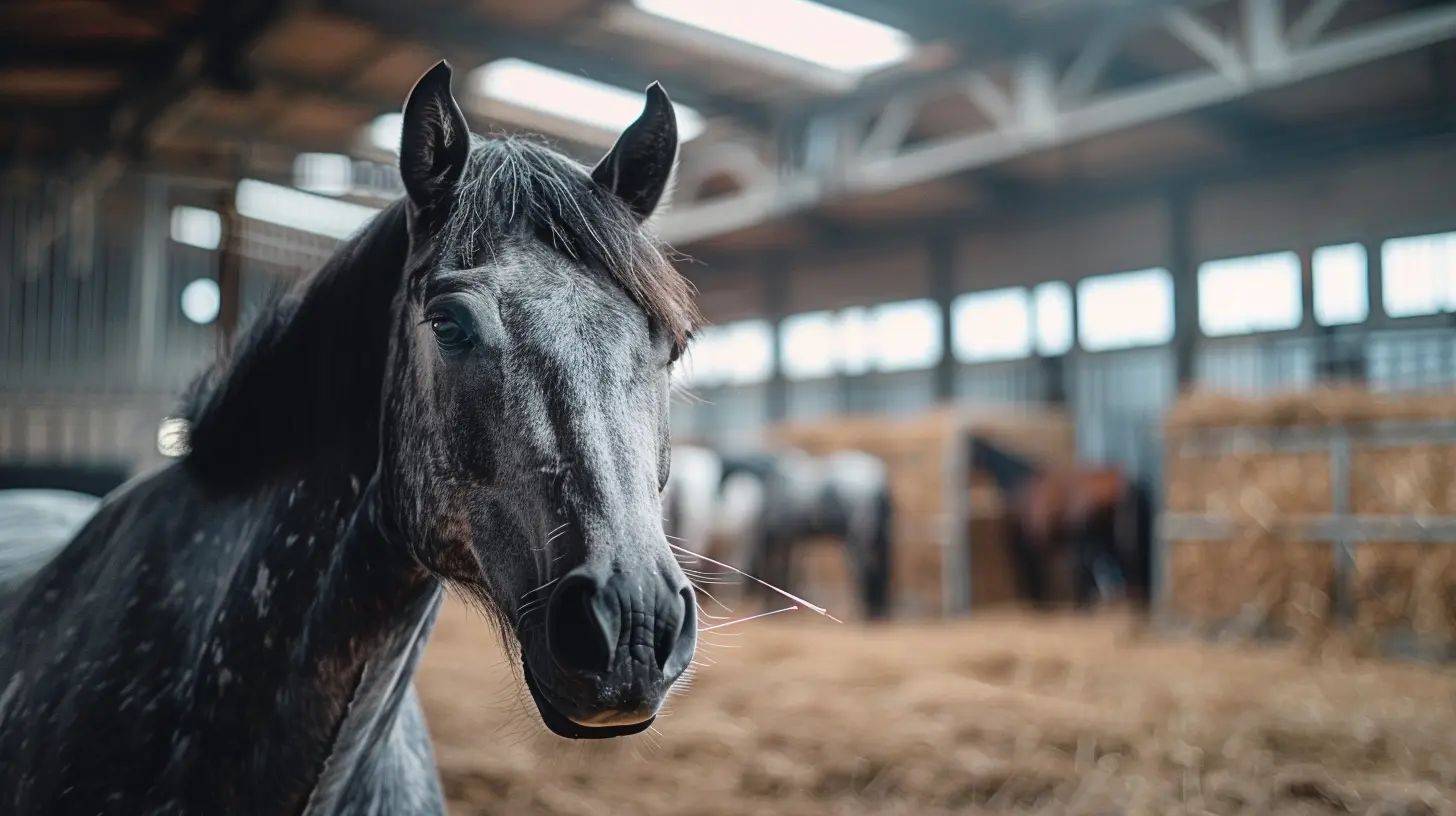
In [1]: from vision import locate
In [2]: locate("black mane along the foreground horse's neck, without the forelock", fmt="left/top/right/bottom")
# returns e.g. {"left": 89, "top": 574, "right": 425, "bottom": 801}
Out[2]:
{"left": 181, "top": 201, "right": 409, "bottom": 490}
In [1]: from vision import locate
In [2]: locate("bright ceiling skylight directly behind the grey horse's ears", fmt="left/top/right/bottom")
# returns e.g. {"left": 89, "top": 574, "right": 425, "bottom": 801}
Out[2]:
{"left": 472, "top": 59, "right": 704, "bottom": 141}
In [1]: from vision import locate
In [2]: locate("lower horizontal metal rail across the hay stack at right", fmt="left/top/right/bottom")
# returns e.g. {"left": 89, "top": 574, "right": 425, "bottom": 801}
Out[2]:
{"left": 1158, "top": 513, "right": 1456, "bottom": 544}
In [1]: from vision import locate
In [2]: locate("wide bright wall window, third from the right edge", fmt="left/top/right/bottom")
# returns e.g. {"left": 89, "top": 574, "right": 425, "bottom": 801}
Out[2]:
{"left": 1198, "top": 252, "right": 1305, "bottom": 337}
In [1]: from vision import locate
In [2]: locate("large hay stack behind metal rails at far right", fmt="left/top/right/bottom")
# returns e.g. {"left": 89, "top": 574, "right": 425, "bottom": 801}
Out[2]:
{"left": 1166, "top": 388, "right": 1456, "bottom": 648}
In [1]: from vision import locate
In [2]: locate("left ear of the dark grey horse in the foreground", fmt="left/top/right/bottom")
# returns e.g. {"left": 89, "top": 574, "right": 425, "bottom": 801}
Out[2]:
{"left": 399, "top": 60, "right": 470, "bottom": 207}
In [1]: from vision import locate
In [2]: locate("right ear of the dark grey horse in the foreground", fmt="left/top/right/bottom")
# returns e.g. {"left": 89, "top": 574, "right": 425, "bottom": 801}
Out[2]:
{"left": 591, "top": 82, "right": 677, "bottom": 221}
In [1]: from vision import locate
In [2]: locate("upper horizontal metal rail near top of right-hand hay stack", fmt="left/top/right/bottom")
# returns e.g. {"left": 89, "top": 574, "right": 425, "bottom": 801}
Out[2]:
{"left": 1163, "top": 420, "right": 1456, "bottom": 458}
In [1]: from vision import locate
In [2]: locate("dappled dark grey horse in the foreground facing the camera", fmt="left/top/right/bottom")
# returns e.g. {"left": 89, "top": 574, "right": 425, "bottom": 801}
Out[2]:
{"left": 0, "top": 61, "right": 699, "bottom": 816}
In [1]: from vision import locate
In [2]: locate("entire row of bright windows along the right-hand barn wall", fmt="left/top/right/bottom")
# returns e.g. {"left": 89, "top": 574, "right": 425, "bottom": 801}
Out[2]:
{"left": 680, "top": 233, "right": 1456, "bottom": 386}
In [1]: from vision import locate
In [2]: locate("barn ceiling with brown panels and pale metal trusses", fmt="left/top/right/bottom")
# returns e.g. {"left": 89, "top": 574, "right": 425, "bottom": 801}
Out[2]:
{"left": 0, "top": 0, "right": 1456, "bottom": 249}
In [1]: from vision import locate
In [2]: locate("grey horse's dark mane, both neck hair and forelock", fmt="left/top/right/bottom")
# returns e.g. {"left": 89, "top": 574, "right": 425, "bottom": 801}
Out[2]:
{"left": 179, "top": 136, "right": 700, "bottom": 490}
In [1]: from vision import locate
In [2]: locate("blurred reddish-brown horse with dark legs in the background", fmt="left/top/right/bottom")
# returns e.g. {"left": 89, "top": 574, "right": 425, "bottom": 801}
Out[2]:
{"left": 970, "top": 434, "right": 1153, "bottom": 611}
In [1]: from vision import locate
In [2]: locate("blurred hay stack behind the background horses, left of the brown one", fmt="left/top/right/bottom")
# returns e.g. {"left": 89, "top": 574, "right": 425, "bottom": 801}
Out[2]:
{"left": 773, "top": 407, "right": 1076, "bottom": 616}
